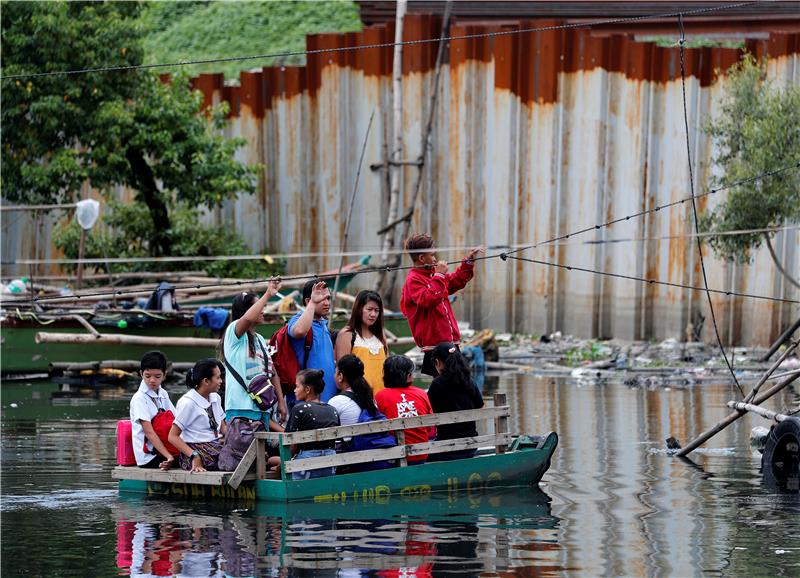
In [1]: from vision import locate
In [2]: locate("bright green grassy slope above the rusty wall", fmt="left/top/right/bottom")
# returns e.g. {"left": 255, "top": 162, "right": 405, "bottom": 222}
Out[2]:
{"left": 142, "top": 0, "right": 361, "bottom": 78}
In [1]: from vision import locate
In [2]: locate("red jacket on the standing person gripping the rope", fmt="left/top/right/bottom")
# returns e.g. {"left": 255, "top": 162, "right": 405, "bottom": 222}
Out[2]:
{"left": 400, "top": 259, "right": 475, "bottom": 349}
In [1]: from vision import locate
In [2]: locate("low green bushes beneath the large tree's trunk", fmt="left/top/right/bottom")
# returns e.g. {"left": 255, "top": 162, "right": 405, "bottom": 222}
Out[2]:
{"left": 53, "top": 201, "right": 286, "bottom": 279}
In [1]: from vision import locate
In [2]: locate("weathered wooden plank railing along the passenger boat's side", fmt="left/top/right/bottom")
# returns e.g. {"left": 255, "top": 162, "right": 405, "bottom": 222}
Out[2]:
{"left": 228, "top": 394, "right": 512, "bottom": 489}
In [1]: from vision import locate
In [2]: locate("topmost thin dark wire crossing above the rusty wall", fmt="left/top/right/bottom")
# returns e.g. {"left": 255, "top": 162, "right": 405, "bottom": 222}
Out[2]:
{"left": 0, "top": 0, "right": 772, "bottom": 80}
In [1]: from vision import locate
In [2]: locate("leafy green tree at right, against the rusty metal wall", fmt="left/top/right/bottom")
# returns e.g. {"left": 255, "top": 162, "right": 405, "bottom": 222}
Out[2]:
{"left": 700, "top": 56, "right": 800, "bottom": 263}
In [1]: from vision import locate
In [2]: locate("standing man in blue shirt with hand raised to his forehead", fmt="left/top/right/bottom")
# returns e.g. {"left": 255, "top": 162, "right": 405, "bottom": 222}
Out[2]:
{"left": 289, "top": 279, "right": 338, "bottom": 403}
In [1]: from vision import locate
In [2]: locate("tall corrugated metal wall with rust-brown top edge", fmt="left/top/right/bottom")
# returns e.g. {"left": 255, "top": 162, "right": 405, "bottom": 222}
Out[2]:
{"left": 3, "top": 15, "right": 800, "bottom": 345}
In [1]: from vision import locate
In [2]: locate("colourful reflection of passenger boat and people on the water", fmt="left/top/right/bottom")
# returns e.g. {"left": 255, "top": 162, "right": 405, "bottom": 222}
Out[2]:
{"left": 115, "top": 488, "right": 567, "bottom": 576}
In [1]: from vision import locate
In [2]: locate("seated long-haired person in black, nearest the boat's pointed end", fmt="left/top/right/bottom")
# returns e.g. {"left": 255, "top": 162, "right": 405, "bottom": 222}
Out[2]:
{"left": 428, "top": 343, "right": 483, "bottom": 461}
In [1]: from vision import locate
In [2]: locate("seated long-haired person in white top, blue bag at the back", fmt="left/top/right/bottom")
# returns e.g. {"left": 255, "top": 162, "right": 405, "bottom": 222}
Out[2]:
{"left": 328, "top": 354, "right": 397, "bottom": 473}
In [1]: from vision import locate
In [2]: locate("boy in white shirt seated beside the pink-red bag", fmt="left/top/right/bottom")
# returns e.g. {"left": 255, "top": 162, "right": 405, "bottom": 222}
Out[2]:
{"left": 130, "top": 351, "right": 177, "bottom": 470}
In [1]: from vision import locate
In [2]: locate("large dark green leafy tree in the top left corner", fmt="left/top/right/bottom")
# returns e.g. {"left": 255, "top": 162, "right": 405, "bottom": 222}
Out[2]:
{"left": 2, "top": 2, "right": 258, "bottom": 270}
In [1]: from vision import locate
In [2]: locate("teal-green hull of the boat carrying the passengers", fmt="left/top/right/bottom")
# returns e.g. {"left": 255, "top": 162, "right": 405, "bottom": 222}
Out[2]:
{"left": 119, "top": 433, "right": 558, "bottom": 505}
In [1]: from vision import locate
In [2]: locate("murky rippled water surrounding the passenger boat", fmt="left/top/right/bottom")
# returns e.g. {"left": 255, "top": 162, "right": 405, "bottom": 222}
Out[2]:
{"left": 0, "top": 376, "right": 800, "bottom": 577}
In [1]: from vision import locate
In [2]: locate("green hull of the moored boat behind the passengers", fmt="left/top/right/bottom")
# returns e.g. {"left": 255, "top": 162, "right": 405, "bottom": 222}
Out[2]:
{"left": 0, "top": 314, "right": 410, "bottom": 374}
